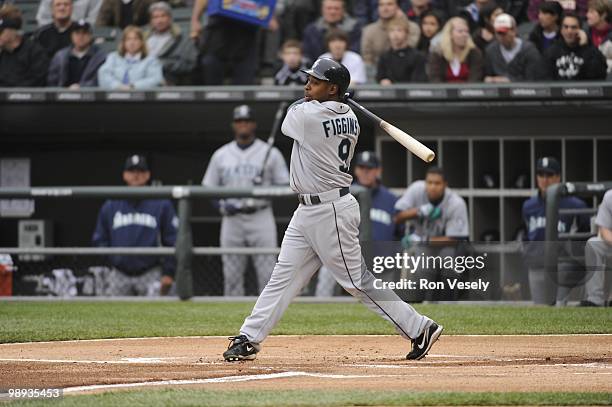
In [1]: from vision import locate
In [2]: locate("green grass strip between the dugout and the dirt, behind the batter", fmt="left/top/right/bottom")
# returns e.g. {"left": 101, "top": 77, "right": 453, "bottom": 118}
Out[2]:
{"left": 0, "top": 301, "right": 612, "bottom": 343}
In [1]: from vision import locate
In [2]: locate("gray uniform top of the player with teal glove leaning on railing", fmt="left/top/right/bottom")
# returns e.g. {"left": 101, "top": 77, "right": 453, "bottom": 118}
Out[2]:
{"left": 395, "top": 181, "right": 470, "bottom": 238}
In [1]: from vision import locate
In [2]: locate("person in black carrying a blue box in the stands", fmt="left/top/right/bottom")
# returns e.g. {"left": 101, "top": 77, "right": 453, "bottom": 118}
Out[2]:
{"left": 190, "top": 0, "right": 259, "bottom": 85}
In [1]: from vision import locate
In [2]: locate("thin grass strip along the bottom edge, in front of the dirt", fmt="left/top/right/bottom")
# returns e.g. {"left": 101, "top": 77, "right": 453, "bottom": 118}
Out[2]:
{"left": 11, "top": 389, "right": 612, "bottom": 407}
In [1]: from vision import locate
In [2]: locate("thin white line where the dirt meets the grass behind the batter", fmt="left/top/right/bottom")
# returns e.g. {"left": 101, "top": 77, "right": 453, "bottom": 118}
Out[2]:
{"left": 0, "top": 334, "right": 612, "bottom": 347}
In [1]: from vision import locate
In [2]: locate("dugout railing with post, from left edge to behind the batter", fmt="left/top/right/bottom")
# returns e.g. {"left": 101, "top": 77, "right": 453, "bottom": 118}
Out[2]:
{"left": 0, "top": 185, "right": 371, "bottom": 300}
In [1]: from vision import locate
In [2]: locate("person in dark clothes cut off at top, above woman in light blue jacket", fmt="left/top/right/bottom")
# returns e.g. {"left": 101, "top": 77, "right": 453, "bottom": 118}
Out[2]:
{"left": 96, "top": 0, "right": 155, "bottom": 29}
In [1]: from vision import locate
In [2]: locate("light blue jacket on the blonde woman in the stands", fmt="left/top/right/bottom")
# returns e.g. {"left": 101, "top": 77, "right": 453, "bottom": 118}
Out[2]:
{"left": 98, "top": 51, "right": 164, "bottom": 89}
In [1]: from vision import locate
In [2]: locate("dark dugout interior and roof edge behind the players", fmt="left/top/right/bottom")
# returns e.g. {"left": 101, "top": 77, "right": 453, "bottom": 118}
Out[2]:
{"left": 0, "top": 82, "right": 612, "bottom": 286}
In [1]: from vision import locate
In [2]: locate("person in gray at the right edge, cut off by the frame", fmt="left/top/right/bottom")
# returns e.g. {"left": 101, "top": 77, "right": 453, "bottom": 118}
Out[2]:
{"left": 580, "top": 190, "right": 612, "bottom": 307}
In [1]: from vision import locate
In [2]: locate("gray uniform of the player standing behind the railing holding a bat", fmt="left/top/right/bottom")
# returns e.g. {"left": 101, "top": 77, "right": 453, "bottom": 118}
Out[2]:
{"left": 202, "top": 139, "right": 289, "bottom": 296}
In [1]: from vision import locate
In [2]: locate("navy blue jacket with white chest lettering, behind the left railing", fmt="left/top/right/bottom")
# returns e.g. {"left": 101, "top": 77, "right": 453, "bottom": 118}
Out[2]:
{"left": 92, "top": 199, "right": 178, "bottom": 276}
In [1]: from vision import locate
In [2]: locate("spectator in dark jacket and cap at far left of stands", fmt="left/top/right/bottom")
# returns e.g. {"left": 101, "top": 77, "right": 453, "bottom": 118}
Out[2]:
{"left": 0, "top": 5, "right": 49, "bottom": 87}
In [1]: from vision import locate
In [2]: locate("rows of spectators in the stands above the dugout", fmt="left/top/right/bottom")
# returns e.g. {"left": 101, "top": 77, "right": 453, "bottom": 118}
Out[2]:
{"left": 0, "top": 0, "right": 612, "bottom": 89}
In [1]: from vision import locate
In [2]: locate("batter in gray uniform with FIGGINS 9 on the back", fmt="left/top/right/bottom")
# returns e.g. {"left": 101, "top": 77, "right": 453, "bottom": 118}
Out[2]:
{"left": 223, "top": 59, "right": 443, "bottom": 361}
